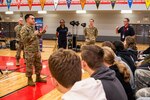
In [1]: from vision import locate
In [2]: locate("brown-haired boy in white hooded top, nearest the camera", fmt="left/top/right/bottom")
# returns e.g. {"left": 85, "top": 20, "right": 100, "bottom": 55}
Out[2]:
{"left": 49, "top": 49, "right": 107, "bottom": 100}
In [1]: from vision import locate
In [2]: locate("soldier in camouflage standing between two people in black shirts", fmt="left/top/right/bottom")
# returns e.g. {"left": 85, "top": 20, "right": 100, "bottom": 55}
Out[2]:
{"left": 84, "top": 19, "right": 98, "bottom": 45}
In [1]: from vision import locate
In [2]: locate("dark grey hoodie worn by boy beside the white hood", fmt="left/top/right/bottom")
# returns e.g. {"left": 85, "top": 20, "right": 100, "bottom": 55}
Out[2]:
{"left": 91, "top": 66, "right": 128, "bottom": 100}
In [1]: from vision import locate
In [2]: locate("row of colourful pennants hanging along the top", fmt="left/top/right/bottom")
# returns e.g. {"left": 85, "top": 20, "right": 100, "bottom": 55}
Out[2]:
{"left": 0, "top": 0, "right": 150, "bottom": 10}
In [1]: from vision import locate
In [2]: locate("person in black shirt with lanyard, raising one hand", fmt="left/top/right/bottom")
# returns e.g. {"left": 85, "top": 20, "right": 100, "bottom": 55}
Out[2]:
{"left": 116, "top": 18, "right": 135, "bottom": 42}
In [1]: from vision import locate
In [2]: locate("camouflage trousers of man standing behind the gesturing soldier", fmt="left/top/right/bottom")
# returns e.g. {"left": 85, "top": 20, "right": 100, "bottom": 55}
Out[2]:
{"left": 16, "top": 42, "right": 25, "bottom": 61}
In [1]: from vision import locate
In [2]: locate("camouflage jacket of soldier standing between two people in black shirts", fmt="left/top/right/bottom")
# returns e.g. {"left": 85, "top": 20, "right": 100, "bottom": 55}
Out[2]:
{"left": 84, "top": 27, "right": 98, "bottom": 42}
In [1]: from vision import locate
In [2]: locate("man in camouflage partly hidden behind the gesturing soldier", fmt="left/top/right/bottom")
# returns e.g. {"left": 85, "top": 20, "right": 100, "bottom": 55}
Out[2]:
{"left": 14, "top": 18, "right": 24, "bottom": 66}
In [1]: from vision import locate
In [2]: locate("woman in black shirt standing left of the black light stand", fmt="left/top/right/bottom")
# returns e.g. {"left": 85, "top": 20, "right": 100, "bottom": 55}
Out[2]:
{"left": 56, "top": 19, "right": 68, "bottom": 49}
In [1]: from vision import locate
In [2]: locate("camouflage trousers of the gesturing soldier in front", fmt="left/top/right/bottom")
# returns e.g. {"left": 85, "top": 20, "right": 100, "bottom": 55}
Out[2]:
{"left": 25, "top": 52, "right": 42, "bottom": 77}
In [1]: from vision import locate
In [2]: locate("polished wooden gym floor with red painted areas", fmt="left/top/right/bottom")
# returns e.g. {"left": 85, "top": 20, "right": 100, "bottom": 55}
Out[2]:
{"left": 0, "top": 40, "right": 148, "bottom": 100}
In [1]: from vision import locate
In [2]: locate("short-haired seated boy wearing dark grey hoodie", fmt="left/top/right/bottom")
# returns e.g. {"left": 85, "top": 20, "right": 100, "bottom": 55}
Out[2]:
{"left": 81, "top": 45, "right": 128, "bottom": 100}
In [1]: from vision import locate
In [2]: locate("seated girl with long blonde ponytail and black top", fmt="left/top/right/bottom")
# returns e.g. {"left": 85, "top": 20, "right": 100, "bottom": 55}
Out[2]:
{"left": 103, "top": 47, "right": 135, "bottom": 100}
